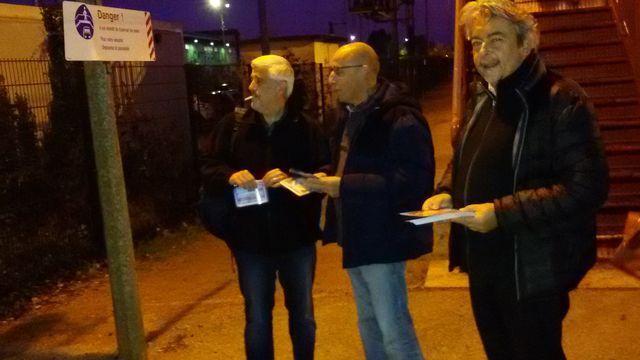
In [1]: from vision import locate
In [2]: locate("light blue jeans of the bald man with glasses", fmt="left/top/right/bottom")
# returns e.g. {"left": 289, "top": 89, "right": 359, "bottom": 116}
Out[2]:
{"left": 347, "top": 261, "right": 423, "bottom": 360}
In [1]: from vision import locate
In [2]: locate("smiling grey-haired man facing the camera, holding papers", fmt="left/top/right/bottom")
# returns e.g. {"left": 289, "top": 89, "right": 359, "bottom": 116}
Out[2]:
{"left": 423, "top": 0, "right": 607, "bottom": 360}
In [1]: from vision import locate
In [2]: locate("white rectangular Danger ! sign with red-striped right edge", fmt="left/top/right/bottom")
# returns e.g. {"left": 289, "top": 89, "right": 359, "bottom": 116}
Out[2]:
{"left": 62, "top": 1, "right": 156, "bottom": 61}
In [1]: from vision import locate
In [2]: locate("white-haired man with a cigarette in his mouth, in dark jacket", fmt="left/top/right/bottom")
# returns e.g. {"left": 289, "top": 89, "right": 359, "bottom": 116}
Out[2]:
{"left": 201, "top": 55, "right": 328, "bottom": 360}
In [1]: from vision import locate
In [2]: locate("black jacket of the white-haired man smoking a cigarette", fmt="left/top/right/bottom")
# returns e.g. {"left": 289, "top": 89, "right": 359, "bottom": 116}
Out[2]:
{"left": 201, "top": 100, "right": 329, "bottom": 254}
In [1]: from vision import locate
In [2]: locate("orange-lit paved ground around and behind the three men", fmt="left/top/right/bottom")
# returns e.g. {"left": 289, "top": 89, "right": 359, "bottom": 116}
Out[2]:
{"left": 0, "top": 83, "right": 640, "bottom": 360}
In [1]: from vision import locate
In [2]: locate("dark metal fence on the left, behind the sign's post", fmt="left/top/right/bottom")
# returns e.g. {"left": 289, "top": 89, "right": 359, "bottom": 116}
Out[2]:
{"left": 0, "top": 60, "right": 197, "bottom": 309}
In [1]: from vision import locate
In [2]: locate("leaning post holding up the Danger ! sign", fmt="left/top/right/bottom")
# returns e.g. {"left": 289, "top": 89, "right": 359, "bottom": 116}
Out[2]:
{"left": 84, "top": 0, "right": 147, "bottom": 360}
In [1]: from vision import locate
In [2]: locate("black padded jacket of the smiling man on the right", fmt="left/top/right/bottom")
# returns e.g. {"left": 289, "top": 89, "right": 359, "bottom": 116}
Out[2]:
{"left": 436, "top": 53, "right": 608, "bottom": 299}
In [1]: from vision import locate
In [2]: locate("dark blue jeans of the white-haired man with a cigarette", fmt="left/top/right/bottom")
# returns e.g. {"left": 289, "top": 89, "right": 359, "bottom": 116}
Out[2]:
{"left": 234, "top": 244, "right": 316, "bottom": 360}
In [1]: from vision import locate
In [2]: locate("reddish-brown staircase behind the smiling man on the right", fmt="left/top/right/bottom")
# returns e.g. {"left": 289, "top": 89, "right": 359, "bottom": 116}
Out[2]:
{"left": 534, "top": 6, "right": 640, "bottom": 257}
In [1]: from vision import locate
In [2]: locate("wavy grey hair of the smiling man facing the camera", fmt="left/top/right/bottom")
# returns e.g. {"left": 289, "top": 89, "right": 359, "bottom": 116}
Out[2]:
{"left": 459, "top": 0, "right": 540, "bottom": 50}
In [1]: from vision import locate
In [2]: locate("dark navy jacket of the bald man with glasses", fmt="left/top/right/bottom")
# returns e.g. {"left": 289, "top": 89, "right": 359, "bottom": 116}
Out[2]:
{"left": 325, "top": 80, "right": 434, "bottom": 268}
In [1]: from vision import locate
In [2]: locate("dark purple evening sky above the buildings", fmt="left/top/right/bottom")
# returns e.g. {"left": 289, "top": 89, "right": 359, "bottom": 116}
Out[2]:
{"left": 4, "top": 0, "right": 454, "bottom": 44}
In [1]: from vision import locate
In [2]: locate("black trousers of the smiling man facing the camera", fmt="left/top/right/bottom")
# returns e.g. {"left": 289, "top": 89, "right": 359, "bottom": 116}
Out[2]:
{"left": 470, "top": 272, "right": 569, "bottom": 360}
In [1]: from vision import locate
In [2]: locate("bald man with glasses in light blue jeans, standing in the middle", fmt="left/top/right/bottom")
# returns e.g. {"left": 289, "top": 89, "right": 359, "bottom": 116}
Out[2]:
{"left": 306, "top": 42, "right": 434, "bottom": 359}
